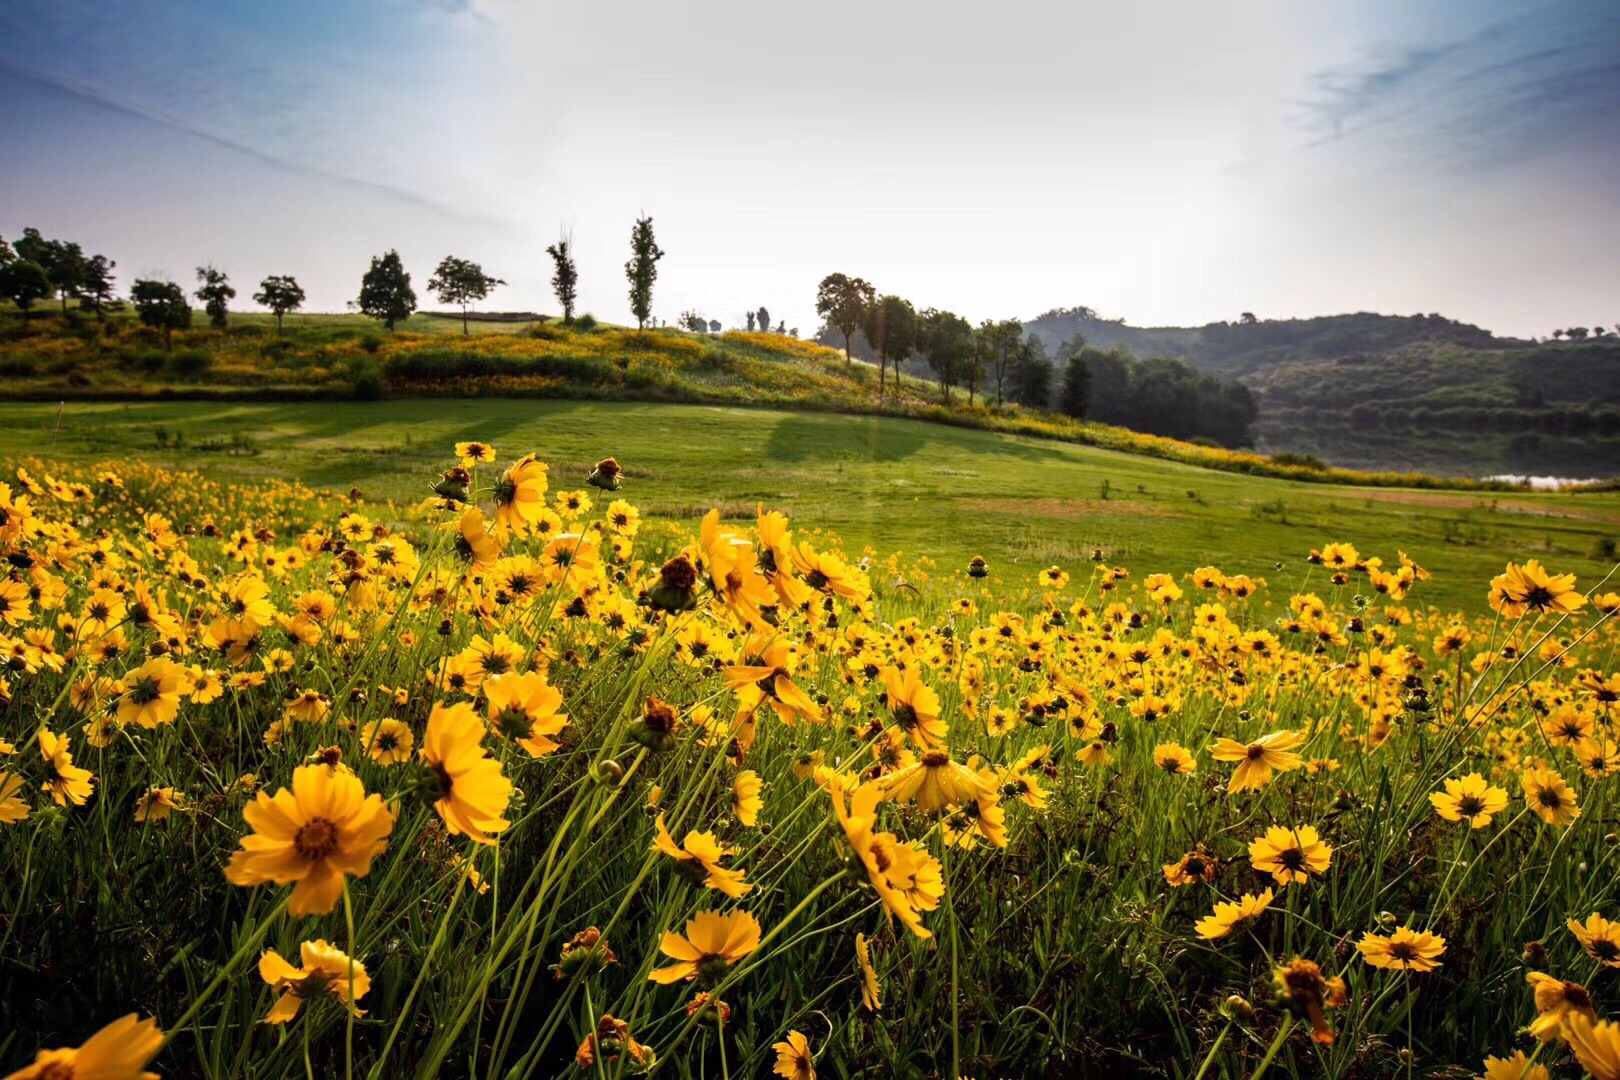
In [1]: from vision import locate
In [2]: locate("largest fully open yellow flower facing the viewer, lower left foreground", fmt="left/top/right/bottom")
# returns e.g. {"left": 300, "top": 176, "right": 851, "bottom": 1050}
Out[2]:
{"left": 225, "top": 764, "right": 394, "bottom": 915}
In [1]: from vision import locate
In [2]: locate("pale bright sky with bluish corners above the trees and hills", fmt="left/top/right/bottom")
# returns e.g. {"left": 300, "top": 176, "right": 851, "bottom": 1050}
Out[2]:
{"left": 0, "top": 0, "right": 1620, "bottom": 335}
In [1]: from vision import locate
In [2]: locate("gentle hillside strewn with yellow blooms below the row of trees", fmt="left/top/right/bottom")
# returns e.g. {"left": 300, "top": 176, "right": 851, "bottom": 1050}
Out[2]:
{"left": 0, "top": 306, "right": 1555, "bottom": 487}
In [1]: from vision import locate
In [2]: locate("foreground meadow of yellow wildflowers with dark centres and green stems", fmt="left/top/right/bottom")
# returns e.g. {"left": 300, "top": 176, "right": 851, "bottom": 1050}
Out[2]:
{"left": 0, "top": 442, "right": 1620, "bottom": 1080}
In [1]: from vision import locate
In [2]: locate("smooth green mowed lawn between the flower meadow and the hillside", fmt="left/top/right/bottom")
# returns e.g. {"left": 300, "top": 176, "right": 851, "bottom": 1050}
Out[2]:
{"left": 0, "top": 398, "right": 1620, "bottom": 610}
